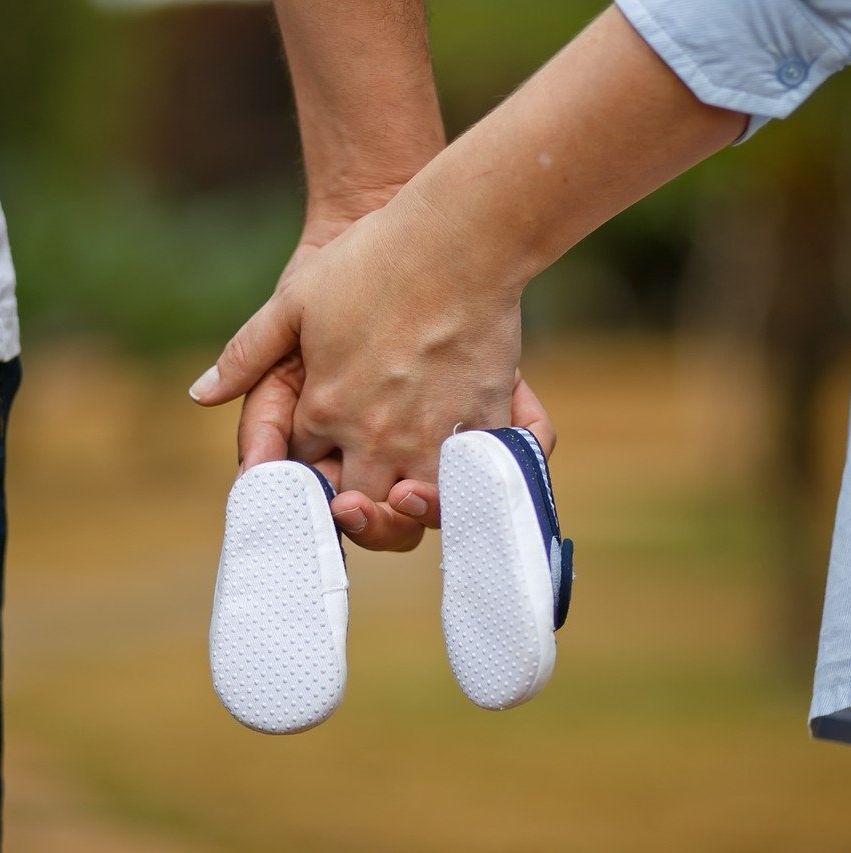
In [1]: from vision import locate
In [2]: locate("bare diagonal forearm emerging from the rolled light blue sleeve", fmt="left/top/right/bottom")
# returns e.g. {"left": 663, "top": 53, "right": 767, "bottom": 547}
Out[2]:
{"left": 392, "top": 4, "right": 745, "bottom": 298}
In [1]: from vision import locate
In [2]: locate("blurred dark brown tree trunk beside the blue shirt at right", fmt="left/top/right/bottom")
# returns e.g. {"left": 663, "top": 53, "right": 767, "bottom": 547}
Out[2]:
{"left": 684, "top": 116, "right": 848, "bottom": 672}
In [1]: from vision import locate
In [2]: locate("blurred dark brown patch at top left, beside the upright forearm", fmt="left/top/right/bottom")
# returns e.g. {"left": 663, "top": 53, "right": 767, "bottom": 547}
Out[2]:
{"left": 129, "top": 3, "right": 299, "bottom": 192}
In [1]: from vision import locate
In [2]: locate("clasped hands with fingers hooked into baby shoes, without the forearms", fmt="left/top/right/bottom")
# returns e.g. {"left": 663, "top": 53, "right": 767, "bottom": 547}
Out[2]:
{"left": 190, "top": 185, "right": 555, "bottom": 551}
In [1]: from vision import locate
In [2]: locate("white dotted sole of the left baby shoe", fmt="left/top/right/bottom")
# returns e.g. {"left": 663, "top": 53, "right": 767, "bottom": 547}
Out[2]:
{"left": 210, "top": 462, "right": 348, "bottom": 734}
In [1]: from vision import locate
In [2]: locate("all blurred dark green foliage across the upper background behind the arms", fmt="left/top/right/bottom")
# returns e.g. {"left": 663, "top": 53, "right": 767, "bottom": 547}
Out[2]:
{"left": 0, "top": 0, "right": 851, "bottom": 354}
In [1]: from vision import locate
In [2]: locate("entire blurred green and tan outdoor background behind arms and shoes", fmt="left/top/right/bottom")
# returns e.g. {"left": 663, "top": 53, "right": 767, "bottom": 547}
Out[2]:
{"left": 0, "top": 0, "right": 851, "bottom": 851}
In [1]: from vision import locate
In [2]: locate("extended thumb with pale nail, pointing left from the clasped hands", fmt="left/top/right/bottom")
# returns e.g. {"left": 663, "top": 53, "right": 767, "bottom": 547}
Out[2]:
{"left": 189, "top": 293, "right": 298, "bottom": 406}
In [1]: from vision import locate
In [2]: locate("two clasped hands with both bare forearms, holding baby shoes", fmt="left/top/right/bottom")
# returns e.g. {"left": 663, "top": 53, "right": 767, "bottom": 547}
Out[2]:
{"left": 185, "top": 5, "right": 747, "bottom": 550}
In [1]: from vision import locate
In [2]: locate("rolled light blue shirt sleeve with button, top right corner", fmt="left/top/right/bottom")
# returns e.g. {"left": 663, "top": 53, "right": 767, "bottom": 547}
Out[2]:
{"left": 615, "top": 0, "right": 851, "bottom": 141}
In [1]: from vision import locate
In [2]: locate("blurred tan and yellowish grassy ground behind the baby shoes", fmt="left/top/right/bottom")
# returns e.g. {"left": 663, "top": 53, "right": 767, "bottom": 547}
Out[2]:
{"left": 7, "top": 338, "right": 851, "bottom": 853}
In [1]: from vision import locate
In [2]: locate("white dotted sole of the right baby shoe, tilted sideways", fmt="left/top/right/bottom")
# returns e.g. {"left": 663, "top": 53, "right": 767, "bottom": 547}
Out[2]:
{"left": 439, "top": 431, "right": 556, "bottom": 710}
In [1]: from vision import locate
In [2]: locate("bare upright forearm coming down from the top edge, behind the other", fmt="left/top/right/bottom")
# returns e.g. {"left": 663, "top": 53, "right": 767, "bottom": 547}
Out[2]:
{"left": 275, "top": 0, "right": 445, "bottom": 226}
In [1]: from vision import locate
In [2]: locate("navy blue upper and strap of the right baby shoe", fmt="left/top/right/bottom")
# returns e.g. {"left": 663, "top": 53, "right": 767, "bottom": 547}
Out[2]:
{"left": 485, "top": 427, "right": 573, "bottom": 629}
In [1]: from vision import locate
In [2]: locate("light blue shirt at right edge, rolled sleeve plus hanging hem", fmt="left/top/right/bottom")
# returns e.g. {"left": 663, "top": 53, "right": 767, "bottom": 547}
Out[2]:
{"left": 615, "top": 0, "right": 851, "bottom": 743}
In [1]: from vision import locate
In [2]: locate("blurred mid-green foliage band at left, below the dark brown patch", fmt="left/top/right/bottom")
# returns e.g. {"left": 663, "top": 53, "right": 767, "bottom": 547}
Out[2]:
{"left": 3, "top": 180, "right": 299, "bottom": 355}
